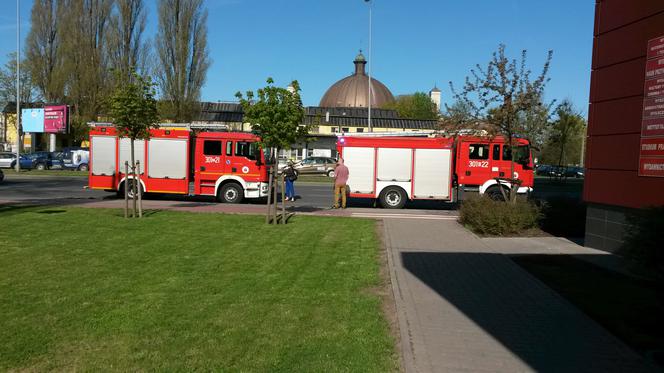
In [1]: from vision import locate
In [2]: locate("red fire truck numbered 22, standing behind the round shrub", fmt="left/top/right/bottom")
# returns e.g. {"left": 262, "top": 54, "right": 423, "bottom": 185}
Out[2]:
{"left": 337, "top": 136, "right": 534, "bottom": 208}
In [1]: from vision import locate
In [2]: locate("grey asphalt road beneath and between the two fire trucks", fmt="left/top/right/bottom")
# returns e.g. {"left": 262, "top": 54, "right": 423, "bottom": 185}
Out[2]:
{"left": 0, "top": 171, "right": 455, "bottom": 211}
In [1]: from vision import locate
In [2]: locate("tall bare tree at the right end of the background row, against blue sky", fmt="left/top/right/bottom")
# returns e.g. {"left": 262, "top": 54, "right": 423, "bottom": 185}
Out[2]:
{"left": 156, "top": 0, "right": 210, "bottom": 122}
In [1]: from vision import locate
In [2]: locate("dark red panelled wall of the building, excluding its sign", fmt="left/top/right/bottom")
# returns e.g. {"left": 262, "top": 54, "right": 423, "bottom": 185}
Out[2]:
{"left": 583, "top": 0, "right": 664, "bottom": 208}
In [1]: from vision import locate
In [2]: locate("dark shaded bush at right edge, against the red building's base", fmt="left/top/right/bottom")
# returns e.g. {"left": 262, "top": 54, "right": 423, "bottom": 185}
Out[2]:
{"left": 620, "top": 206, "right": 664, "bottom": 284}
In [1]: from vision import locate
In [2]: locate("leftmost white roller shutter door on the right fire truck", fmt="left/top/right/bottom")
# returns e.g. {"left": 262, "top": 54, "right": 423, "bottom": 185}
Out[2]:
{"left": 343, "top": 147, "right": 376, "bottom": 194}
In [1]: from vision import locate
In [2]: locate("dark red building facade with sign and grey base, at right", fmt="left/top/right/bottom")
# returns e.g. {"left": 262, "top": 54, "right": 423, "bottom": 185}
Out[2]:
{"left": 583, "top": 0, "right": 664, "bottom": 251}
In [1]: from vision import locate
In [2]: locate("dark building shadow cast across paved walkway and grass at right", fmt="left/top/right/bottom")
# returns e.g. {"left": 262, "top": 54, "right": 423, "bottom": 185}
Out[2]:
{"left": 402, "top": 252, "right": 664, "bottom": 372}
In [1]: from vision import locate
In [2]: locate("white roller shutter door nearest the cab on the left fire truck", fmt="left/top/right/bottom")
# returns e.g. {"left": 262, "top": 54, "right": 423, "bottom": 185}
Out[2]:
{"left": 148, "top": 139, "right": 187, "bottom": 179}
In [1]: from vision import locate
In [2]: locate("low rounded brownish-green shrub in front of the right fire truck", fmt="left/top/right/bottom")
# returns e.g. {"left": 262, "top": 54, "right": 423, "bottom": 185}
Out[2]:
{"left": 459, "top": 197, "right": 540, "bottom": 236}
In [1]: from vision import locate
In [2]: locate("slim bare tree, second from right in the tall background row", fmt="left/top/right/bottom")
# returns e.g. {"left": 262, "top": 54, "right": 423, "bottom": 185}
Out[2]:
{"left": 108, "top": 0, "right": 148, "bottom": 80}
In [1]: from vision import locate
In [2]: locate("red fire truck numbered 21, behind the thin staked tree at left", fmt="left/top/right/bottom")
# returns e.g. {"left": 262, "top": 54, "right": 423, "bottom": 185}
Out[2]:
{"left": 89, "top": 125, "right": 268, "bottom": 203}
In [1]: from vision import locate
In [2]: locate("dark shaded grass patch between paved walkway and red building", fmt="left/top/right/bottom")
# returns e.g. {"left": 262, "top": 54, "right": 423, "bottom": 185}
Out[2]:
{"left": 513, "top": 255, "right": 664, "bottom": 367}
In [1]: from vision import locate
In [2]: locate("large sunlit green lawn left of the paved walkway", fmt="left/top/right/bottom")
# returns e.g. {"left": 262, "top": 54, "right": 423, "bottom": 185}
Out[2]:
{"left": 0, "top": 207, "right": 398, "bottom": 372}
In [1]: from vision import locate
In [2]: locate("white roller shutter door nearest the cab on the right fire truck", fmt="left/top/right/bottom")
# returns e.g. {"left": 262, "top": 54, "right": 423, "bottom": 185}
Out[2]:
{"left": 413, "top": 149, "right": 451, "bottom": 199}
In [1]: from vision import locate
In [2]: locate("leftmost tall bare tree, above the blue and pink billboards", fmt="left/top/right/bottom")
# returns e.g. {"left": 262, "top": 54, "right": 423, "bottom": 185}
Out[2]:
{"left": 25, "top": 0, "right": 65, "bottom": 102}
